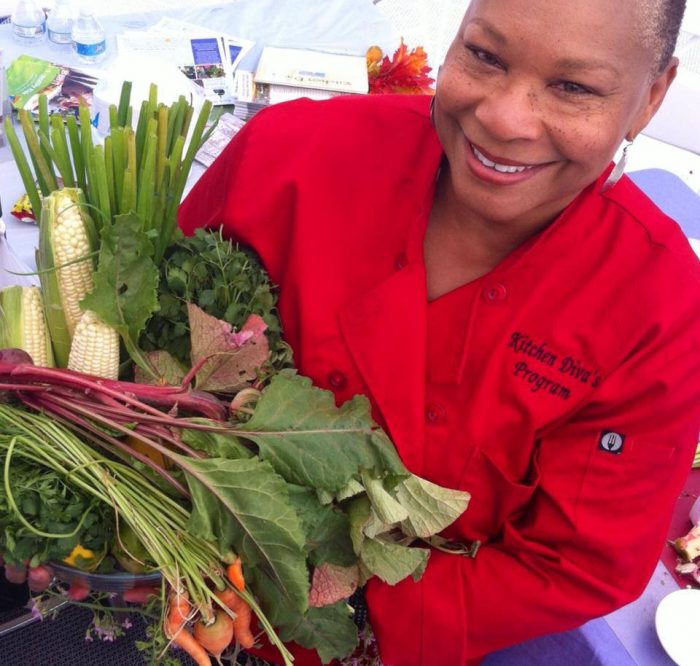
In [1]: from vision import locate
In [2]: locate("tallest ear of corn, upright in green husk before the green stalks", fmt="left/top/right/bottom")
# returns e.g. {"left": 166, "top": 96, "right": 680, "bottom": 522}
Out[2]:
{"left": 37, "top": 188, "right": 97, "bottom": 368}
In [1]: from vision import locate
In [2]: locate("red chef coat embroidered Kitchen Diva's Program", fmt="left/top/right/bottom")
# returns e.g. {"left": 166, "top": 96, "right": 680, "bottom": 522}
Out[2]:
{"left": 180, "top": 97, "right": 700, "bottom": 666}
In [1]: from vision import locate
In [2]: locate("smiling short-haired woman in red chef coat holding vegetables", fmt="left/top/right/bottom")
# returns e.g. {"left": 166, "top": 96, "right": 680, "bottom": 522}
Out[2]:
{"left": 179, "top": 0, "right": 700, "bottom": 666}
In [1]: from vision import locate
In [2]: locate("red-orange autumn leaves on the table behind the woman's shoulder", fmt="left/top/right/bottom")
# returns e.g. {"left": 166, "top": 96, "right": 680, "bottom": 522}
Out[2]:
{"left": 367, "top": 39, "right": 435, "bottom": 95}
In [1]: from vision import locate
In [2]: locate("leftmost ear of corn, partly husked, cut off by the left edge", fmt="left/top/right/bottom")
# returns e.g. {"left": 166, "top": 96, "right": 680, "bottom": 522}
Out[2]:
{"left": 0, "top": 286, "right": 54, "bottom": 368}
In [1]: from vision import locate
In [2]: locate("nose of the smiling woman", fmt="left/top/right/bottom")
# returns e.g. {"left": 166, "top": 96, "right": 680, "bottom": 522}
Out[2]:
{"left": 475, "top": 84, "right": 543, "bottom": 141}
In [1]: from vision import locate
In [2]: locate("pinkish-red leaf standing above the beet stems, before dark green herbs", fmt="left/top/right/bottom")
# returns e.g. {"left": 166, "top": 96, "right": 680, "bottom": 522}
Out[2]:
{"left": 187, "top": 303, "right": 270, "bottom": 393}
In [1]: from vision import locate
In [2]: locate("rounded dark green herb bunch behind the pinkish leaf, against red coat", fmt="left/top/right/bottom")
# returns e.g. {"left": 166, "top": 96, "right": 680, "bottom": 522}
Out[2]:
{"left": 140, "top": 229, "right": 292, "bottom": 371}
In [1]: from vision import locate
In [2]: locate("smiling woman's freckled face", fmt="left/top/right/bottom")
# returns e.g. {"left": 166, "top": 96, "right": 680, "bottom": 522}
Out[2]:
{"left": 435, "top": 0, "right": 675, "bottom": 225}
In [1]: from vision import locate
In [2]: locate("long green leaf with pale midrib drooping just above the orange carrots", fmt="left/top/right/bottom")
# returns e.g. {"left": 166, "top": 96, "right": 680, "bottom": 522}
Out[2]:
{"left": 179, "top": 456, "right": 309, "bottom": 613}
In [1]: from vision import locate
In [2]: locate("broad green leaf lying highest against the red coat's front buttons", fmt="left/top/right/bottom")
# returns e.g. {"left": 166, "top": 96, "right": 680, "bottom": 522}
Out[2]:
{"left": 240, "top": 373, "right": 408, "bottom": 493}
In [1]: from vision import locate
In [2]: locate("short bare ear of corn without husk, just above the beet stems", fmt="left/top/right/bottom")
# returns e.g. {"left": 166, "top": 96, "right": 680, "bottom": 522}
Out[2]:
{"left": 68, "top": 310, "right": 119, "bottom": 379}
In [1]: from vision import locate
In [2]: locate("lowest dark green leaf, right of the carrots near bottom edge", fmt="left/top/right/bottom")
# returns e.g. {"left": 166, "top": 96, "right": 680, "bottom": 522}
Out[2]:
{"left": 280, "top": 601, "right": 358, "bottom": 664}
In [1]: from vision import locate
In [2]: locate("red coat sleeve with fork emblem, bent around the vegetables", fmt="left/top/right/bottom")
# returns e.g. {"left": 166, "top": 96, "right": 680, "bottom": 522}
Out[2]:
{"left": 368, "top": 313, "right": 700, "bottom": 666}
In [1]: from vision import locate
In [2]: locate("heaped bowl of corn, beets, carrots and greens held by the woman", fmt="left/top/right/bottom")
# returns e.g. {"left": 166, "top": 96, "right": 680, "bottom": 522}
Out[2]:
{"left": 0, "top": 86, "right": 469, "bottom": 664}
